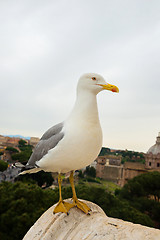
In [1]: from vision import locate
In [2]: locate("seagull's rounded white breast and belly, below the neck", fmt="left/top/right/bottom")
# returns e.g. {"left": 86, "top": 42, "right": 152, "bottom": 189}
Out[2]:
{"left": 38, "top": 121, "right": 102, "bottom": 172}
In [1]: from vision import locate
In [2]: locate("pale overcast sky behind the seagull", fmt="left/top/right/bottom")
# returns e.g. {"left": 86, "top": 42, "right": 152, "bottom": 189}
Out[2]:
{"left": 0, "top": 0, "right": 160, "bottom": 152}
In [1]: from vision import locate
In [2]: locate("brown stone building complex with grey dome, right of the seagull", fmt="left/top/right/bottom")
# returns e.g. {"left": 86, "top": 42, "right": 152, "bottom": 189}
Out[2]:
{"left": 96, "top": 133, "right": 160, "bottom": 186}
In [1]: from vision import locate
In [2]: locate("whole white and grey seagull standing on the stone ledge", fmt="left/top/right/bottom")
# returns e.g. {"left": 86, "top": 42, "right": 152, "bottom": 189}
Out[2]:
{"left": 21, "top": 73, "right": 119, "bottom": 214}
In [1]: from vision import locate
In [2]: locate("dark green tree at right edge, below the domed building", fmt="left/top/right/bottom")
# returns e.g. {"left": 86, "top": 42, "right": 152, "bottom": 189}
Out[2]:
{"left": 118, "top": 172, "right": 160, "bottom": 227}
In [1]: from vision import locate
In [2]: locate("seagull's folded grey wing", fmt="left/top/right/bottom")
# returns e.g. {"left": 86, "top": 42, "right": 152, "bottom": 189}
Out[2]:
{"left": 27, "top": 123, "right": 64, "bottom": 168}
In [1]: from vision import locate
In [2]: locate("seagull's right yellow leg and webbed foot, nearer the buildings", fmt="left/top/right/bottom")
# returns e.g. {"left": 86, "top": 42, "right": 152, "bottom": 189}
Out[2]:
{"left": 69, "top": 171, "right": 91, "bottom": 214}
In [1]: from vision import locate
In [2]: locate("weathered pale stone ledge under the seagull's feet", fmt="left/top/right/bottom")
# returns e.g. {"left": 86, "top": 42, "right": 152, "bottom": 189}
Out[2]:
{"left": 23, "top": 200, "right": 160, "bottom": 240}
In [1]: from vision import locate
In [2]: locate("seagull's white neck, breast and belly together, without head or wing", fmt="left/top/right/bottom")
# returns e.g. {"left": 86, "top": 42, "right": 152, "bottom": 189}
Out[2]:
{"left": 37, "top": 92, "right": 102, "bottom": 173}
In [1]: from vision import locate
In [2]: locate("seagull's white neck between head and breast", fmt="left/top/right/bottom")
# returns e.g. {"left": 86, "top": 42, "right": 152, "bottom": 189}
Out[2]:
{"left": 69, "top": 91, "right": 99, "bottom": 124}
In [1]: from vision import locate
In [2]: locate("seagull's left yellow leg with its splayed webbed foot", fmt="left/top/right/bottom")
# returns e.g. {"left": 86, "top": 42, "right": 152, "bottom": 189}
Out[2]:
{"left": 53, "top": 174, "right": 74, "bottom": 214}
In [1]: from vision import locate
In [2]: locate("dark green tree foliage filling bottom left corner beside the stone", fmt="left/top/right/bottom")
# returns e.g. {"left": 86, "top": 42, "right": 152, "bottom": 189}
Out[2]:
{"left": 0, "top": 182, "right": 58, "bottom": 240}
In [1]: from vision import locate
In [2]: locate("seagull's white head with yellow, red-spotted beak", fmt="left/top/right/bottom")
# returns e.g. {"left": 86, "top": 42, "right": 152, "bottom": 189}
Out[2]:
{"left": 77, "top": 73, "right": 119, "bottom": 94}
